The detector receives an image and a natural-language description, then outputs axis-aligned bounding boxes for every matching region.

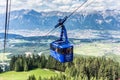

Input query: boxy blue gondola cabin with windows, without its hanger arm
[50,41,73,63]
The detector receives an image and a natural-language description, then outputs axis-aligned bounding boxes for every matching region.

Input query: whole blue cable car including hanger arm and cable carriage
[50,17,73,63]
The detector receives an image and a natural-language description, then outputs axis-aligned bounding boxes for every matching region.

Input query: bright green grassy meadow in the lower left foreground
[0,69,57,80]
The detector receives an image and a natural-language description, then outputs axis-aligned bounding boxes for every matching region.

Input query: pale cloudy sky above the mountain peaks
[0,0,120,13]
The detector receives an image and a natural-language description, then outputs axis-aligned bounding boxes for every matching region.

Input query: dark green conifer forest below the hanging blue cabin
[10,55,120,80]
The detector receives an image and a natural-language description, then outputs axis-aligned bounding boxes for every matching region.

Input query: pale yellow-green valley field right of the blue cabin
[74,42,120,56]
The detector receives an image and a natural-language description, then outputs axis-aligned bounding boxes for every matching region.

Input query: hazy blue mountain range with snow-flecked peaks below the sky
[0,9,120,30]
